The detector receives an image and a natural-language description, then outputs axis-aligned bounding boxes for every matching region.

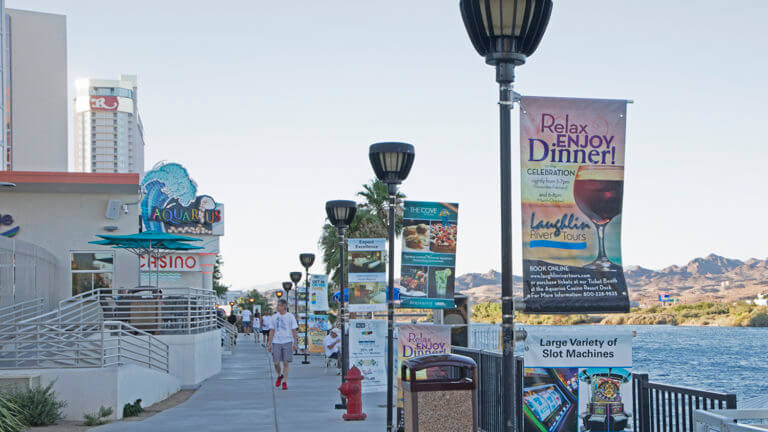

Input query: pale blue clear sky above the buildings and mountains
[7,0,768,289]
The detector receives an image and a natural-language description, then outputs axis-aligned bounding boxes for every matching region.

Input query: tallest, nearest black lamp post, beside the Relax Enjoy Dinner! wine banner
[459,0,552,432]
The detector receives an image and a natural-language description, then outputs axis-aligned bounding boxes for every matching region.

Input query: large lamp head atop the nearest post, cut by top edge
[459,0,552,65]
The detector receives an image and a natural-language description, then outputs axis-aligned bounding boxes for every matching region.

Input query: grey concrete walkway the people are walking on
[89,335,386,432]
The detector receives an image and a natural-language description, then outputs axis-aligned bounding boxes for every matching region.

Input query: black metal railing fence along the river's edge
[451,346,736,432]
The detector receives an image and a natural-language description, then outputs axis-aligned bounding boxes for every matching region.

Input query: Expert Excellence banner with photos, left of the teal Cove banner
[347,239,387,312]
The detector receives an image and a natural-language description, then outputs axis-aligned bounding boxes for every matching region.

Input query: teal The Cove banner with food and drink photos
[400,201,459,309]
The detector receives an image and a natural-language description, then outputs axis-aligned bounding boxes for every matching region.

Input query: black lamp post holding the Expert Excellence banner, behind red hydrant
[325,200,357,409]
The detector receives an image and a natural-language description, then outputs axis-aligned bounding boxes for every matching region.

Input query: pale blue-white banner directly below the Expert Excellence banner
[349,319,387,393]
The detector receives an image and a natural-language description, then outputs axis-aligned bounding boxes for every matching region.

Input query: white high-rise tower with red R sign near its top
[74,75,144,174]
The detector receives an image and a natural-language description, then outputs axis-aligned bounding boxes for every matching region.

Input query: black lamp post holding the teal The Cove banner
[368,142,416,432]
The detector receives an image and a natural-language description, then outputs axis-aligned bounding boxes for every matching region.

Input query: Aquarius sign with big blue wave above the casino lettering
[141,163,224,235]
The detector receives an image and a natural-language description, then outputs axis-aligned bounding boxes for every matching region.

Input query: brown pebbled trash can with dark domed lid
[401,354,477,432]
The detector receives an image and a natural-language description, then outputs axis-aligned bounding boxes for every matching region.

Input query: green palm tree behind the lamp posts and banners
[318,180,405,292]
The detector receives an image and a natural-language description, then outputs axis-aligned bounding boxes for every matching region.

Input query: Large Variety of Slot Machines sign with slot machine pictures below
[523,326,634,432]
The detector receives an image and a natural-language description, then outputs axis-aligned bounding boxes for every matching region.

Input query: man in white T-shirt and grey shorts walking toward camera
[267,299,299,390]
